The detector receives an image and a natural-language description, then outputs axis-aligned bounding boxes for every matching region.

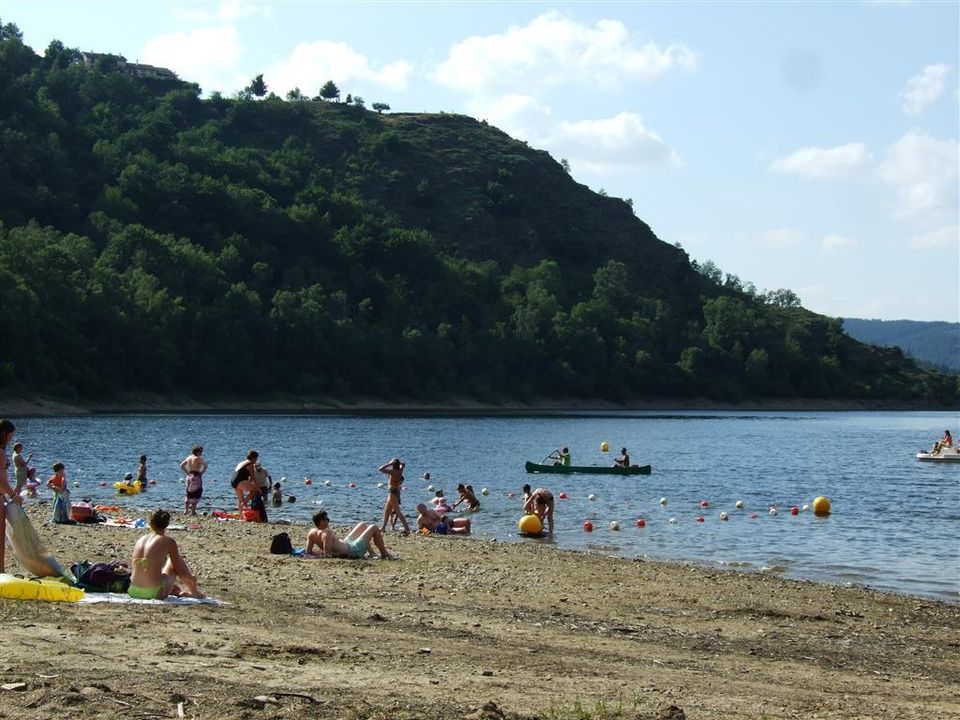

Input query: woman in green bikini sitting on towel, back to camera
[127,510,203,600]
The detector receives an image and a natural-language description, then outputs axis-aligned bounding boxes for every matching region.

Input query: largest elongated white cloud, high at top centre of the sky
[434,12,697,95]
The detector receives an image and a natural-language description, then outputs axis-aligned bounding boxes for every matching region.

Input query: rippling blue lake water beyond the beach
[14,412,960,602]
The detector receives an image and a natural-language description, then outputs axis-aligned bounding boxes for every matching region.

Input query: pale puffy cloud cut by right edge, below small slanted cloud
[878,130,960,218]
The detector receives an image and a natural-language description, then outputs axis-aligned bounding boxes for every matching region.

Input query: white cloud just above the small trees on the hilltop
[263,40,413,96]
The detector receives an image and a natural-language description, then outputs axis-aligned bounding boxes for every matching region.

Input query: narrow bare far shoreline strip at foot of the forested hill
[0,393,960,417]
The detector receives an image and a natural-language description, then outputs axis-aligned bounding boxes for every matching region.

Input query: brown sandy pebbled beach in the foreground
[0,507,960,720]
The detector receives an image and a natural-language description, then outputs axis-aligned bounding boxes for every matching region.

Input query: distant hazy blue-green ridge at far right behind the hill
[843,318,960,374]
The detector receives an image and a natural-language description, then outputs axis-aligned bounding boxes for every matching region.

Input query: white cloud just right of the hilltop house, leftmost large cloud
[139,25,249,94]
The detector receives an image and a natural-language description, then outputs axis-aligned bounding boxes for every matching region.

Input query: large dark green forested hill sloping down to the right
[0,25,957,403]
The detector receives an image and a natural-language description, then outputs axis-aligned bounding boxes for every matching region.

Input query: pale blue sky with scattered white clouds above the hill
[0,0,960,322]
